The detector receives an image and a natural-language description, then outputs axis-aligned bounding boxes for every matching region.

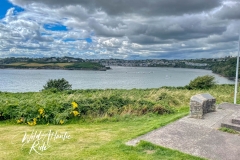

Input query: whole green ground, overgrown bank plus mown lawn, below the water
[0,85,236,159]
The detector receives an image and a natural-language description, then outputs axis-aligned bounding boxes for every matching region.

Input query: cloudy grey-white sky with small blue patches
[0,0,240,59]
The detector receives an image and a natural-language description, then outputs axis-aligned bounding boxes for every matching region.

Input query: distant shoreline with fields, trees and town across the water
[0,56,240,79]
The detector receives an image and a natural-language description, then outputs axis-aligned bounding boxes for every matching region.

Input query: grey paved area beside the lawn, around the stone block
[127,103,240,160]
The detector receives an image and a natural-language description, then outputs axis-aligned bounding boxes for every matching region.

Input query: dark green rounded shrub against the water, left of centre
[43,78,72,91]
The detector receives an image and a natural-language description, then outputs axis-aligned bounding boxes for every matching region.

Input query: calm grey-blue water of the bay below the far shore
[0,67,234,92]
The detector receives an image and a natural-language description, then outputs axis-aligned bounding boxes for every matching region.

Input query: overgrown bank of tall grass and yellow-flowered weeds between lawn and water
[0,85,234,124]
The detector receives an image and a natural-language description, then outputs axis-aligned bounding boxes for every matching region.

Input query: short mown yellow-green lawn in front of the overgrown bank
[0,108,204,160]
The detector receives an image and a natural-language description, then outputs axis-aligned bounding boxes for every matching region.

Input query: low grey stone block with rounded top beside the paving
[190,93,216,118]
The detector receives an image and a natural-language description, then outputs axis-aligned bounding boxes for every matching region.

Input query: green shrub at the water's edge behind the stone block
[188,75,216,89]
